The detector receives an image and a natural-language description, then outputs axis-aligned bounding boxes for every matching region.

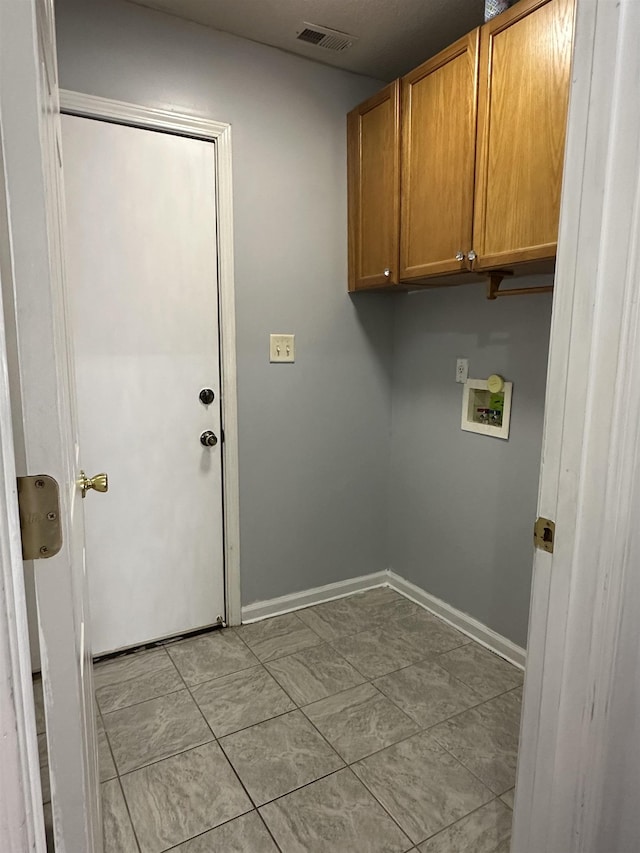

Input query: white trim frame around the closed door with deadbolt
[60,89,241,625]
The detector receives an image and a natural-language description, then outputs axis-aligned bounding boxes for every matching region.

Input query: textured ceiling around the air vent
[126,0,484,80]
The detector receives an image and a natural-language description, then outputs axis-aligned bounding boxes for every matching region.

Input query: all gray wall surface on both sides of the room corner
[57,0,551,644]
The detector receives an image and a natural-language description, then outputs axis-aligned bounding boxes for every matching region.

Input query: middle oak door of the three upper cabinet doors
[400,30,479,280]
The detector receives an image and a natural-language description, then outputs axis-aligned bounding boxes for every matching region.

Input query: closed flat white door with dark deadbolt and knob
[62,115,225,654]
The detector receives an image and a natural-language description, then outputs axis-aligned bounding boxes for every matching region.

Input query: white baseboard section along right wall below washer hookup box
[386,569,527,669]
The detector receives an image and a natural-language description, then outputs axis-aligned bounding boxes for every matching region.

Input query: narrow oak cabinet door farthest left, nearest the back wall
[347,80,400,290]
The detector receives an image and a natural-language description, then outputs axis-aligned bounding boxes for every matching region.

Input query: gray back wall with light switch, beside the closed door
[56,0,391,604]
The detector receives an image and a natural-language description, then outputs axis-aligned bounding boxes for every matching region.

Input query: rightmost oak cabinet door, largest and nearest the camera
[473,0,573,269]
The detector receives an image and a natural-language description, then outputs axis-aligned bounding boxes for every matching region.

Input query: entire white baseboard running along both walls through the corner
[242,569,526,669]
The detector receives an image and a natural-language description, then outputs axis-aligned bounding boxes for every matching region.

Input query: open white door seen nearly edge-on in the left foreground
[0,0,102,853]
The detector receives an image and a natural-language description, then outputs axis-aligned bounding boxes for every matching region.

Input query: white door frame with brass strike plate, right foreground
[512,0,640,853]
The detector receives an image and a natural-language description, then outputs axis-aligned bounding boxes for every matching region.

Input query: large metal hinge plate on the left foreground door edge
[18,474,62,560]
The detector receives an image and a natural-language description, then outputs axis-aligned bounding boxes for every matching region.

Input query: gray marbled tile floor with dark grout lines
[44,587,522,853]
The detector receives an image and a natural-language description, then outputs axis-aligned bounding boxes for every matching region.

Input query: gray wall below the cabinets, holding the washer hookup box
[390,279,551,646]
